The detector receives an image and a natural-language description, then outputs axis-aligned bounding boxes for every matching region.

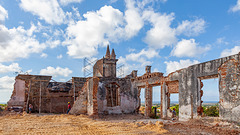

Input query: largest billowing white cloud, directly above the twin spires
[64,0,144,58]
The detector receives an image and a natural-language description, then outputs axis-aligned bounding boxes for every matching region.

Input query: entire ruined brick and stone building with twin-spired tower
[8,47,240,122]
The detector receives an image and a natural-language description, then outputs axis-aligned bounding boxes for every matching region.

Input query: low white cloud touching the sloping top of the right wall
[164,59,200,74]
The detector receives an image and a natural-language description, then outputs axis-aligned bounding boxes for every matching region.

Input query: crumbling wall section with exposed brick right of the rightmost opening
[218,59,240,122]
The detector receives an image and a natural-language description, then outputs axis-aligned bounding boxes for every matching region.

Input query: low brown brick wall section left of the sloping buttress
[8,75,86,113]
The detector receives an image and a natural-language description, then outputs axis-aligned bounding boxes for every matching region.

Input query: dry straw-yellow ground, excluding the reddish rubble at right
[0,114,167,135]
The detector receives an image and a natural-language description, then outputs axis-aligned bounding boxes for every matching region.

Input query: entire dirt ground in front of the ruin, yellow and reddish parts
[0,114,240,135]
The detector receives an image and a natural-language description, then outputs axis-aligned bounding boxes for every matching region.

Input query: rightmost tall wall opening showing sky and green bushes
[198,78,219,117]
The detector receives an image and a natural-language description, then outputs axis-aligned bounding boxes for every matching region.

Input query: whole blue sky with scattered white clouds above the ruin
[0,0,240,102]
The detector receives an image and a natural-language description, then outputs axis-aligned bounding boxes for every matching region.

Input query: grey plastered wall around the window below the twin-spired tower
[97,78,138,114]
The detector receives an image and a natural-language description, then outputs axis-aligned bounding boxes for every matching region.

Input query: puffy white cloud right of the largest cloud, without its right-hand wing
[143,11,177,49]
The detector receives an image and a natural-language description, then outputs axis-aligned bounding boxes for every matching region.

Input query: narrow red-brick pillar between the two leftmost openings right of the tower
[145,85,152,116]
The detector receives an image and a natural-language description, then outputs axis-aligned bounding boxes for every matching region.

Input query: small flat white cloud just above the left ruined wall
[40,66,72,77]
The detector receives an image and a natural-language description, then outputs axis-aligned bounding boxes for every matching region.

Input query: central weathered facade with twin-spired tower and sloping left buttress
[70,47,138,115]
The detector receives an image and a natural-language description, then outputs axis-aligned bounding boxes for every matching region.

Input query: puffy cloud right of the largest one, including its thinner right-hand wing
[143,9,206,49]
